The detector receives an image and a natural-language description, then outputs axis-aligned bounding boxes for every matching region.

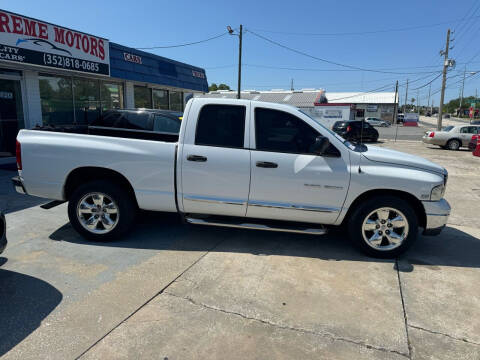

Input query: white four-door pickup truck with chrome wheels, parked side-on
[13,98,450,257]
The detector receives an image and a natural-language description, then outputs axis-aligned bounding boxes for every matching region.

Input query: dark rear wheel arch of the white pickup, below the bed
[63,166,138,207]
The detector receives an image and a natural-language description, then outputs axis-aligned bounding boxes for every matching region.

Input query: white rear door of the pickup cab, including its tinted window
[179,99,250,216]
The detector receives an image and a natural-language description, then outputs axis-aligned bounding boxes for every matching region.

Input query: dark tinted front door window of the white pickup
[255,108,320,154]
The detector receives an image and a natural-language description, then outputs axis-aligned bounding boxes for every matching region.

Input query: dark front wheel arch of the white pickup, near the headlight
[341,189,427,228]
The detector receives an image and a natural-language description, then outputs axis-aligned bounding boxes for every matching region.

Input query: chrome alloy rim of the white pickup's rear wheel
[77,192,120,234]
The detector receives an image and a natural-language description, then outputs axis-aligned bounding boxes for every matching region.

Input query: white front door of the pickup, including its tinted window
[247,104,350,224]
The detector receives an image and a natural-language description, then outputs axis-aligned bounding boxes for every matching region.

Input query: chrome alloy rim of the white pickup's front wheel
[362,207,408,251]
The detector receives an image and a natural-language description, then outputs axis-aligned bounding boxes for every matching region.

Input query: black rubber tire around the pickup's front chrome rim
[348,195,418,258]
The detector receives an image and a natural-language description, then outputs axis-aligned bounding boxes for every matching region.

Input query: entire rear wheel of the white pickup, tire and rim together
[68,180,136,241]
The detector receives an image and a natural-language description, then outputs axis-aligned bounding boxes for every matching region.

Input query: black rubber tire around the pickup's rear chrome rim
[68,180,137,241]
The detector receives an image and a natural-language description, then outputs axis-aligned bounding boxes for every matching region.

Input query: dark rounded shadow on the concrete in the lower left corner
[0,257,63,357]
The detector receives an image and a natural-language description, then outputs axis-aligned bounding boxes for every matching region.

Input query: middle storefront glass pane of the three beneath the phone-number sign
[73,78,100,124]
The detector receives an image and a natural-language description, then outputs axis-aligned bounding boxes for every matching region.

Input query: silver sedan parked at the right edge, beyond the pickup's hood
[422,125,480,150]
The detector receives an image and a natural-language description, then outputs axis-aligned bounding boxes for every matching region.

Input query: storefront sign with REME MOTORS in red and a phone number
[0,10,110,75]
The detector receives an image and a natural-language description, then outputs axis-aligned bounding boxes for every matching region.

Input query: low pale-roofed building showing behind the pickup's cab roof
[199,89,398,126]
